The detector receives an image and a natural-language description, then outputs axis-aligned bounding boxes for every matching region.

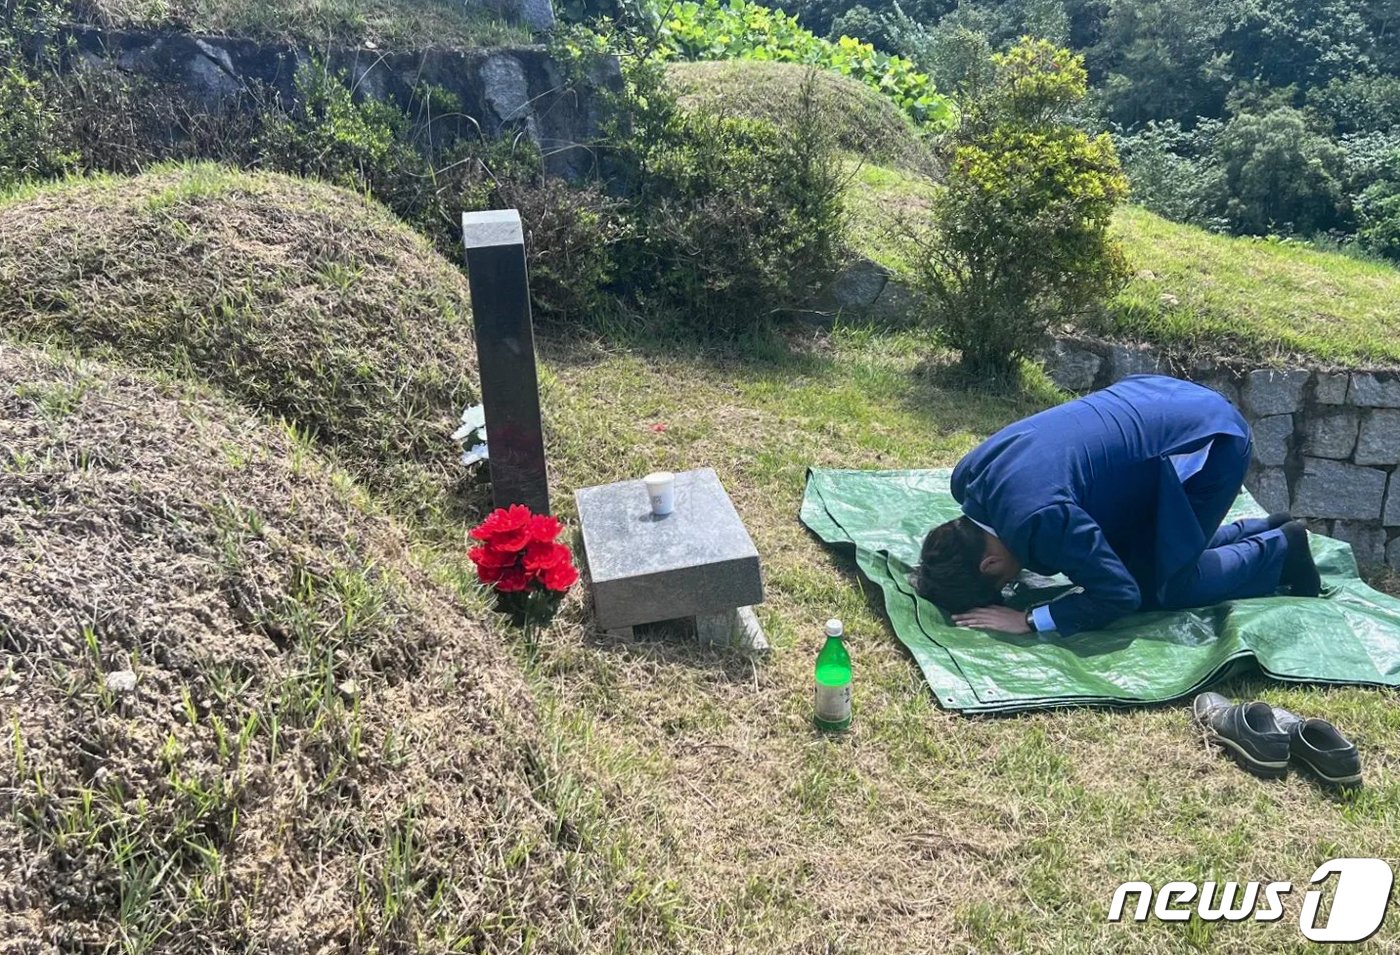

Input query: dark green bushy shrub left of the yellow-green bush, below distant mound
[617,64,844,336]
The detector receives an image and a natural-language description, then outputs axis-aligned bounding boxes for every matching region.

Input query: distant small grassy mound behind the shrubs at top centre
[666,60,928,168]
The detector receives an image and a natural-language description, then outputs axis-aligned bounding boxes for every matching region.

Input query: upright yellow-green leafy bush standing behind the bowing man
[911,39,1127,375]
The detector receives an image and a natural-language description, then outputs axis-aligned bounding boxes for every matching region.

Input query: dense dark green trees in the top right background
[777,0,1400,252]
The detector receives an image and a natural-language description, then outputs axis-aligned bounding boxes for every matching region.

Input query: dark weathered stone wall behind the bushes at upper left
[51,25,622,178]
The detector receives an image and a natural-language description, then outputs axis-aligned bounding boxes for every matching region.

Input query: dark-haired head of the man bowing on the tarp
[910,517,1021,613]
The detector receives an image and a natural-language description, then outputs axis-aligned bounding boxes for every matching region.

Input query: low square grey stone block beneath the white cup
[574,468,763,630]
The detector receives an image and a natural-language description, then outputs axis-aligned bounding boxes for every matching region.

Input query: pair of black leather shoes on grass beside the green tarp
[1191,693,1361,787]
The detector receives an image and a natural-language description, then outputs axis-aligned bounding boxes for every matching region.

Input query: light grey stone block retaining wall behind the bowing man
[1046,339,1400,570]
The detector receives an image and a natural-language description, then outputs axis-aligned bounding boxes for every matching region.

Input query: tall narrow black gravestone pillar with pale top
[462,209,549,514]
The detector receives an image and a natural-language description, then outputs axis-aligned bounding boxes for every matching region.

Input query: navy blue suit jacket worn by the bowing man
[952,375,1250,634]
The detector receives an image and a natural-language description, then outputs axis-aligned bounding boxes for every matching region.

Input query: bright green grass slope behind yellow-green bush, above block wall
[848,164,1400,365]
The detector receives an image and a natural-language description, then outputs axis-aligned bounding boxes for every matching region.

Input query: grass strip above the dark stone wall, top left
[70,0,529,48]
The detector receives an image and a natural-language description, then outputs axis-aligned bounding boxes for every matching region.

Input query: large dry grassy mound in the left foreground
[0,344,574,954]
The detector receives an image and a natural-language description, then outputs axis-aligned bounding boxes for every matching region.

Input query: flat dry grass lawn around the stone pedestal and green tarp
[526,328,1400,954]
